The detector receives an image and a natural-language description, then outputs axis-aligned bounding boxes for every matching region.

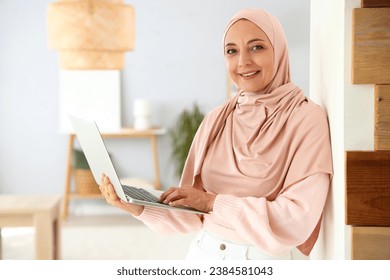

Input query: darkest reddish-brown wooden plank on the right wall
[345,151,390,226]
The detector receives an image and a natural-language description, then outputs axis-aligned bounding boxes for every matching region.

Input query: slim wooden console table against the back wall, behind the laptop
[63,127,166,219]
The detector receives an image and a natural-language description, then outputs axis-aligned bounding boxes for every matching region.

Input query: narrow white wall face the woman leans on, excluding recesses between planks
[310,0,345,259]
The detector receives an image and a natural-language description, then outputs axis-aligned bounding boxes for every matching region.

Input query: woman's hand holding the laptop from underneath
[99,174,144,216]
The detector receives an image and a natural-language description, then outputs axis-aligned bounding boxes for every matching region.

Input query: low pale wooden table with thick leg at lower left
[0,195,61,260]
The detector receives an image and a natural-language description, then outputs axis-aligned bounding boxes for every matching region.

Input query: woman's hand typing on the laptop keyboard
[160,187,216,213]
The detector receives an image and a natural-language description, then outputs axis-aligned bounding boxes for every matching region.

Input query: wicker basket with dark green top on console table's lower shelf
[72,149,100,195]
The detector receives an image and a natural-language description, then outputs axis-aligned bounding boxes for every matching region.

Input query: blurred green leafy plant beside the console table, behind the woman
[169,103,204,177]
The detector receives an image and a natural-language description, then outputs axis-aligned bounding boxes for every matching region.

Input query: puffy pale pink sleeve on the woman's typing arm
[213,173,330,255]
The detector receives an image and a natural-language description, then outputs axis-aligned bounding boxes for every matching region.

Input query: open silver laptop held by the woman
[68,114,205,214]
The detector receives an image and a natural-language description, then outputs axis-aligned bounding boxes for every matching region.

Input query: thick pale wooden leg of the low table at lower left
[34,212,55,260]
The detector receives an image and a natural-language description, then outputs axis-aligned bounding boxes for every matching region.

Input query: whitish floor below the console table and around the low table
[1,215,195,260]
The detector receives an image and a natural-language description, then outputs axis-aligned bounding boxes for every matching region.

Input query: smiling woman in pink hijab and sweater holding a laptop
[100,10,333,259]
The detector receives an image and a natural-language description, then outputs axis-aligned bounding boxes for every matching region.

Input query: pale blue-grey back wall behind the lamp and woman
[0,0,310,197]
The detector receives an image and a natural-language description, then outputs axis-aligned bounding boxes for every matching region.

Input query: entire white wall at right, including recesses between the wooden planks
[310,0,374,259]
